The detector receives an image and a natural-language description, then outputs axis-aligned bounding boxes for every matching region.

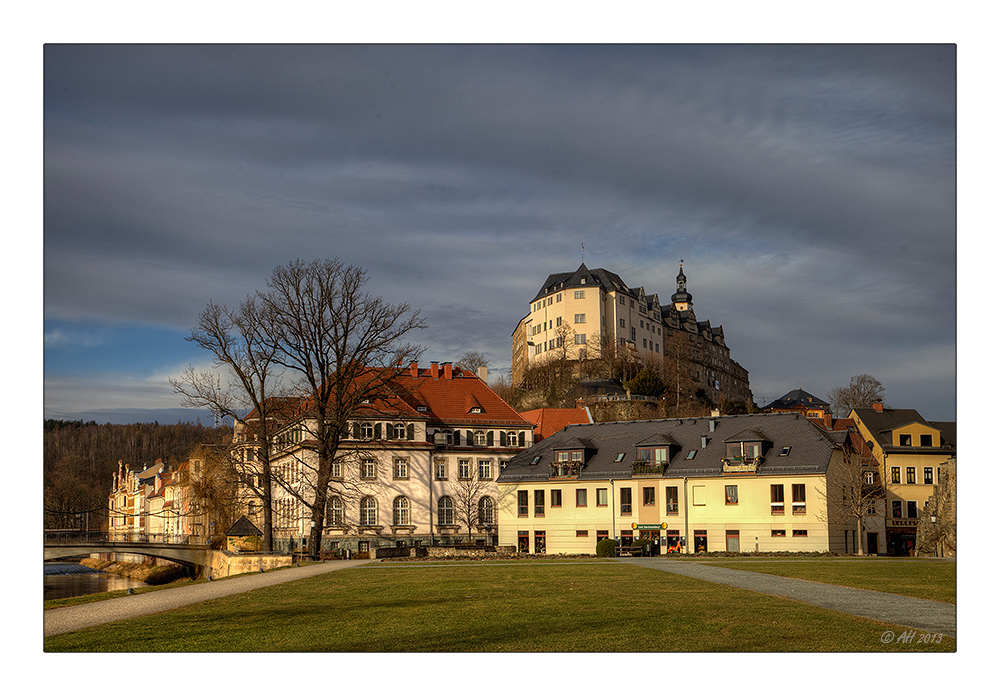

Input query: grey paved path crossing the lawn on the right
[622,558,957,638]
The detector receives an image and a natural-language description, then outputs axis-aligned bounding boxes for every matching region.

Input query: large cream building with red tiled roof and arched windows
[234,363,532,553]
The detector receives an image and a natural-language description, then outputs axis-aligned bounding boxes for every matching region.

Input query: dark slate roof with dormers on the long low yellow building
[497,413,843,483]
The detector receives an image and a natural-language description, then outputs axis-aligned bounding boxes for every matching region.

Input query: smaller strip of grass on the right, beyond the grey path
[711,558,956,604]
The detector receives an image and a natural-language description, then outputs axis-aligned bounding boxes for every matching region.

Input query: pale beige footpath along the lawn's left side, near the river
[44,560,371,636]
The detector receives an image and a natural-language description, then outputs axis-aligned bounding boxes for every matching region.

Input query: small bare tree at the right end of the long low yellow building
[820,433,886,555]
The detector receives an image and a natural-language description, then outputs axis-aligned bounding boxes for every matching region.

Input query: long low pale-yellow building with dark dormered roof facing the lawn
[497,413,858,554]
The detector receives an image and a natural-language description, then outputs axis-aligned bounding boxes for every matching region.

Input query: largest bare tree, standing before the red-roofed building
[256,259,426,555]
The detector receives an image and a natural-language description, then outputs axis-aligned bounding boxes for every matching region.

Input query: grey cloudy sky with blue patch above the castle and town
[43,44,957,422]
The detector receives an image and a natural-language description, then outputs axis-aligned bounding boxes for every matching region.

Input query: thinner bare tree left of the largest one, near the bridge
[170,297,283,553]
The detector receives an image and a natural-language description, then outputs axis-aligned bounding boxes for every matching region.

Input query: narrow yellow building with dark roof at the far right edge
[850,402,955,556]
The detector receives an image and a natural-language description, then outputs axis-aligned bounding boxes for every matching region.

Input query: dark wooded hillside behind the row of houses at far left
[43,420,232,529]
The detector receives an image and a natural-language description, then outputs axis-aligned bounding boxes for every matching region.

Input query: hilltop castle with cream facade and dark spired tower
[511,264,753,403]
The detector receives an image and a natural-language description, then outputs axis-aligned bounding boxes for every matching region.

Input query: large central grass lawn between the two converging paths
[45,563,955,652]
